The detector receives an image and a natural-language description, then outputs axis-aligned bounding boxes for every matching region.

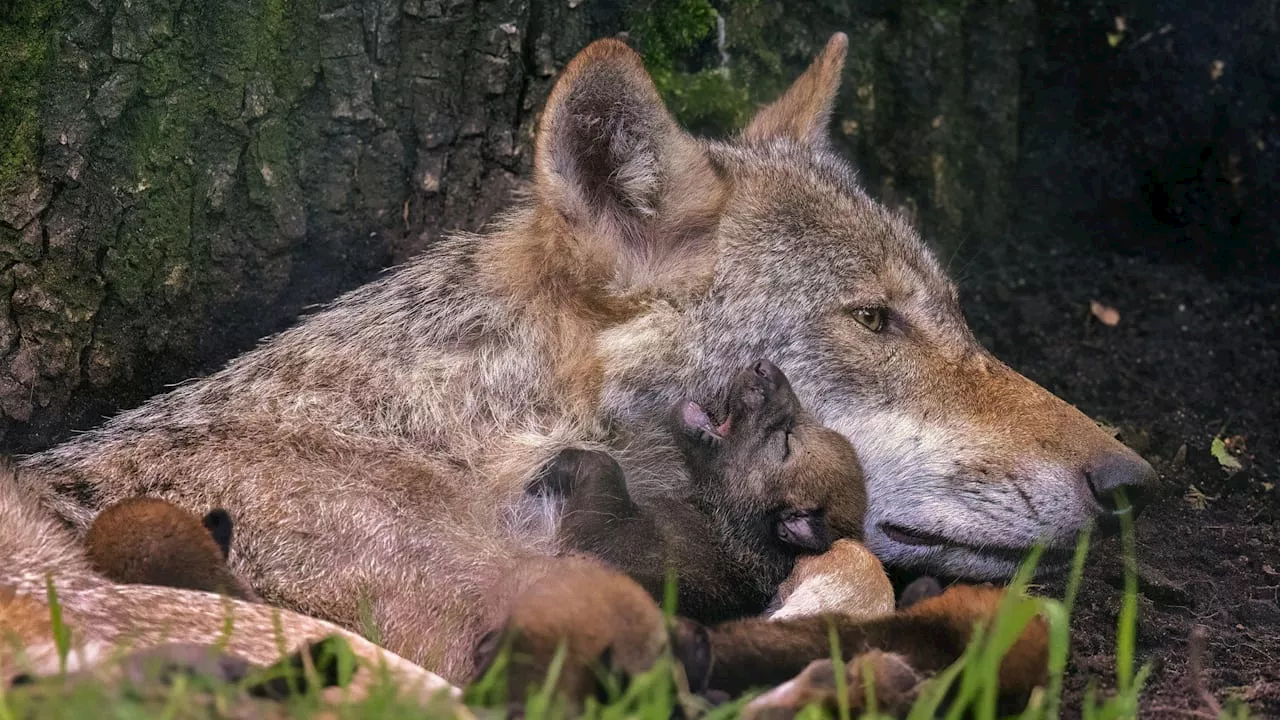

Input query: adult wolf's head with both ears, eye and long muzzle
[524,35,1155,578]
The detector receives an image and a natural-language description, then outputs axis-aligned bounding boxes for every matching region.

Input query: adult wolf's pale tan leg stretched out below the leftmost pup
[0,457,467,716]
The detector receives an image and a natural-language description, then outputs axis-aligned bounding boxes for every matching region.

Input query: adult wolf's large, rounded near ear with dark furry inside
[534,40,722,292]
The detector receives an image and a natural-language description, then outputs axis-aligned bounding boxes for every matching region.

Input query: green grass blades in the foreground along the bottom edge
[0,500,1203,720]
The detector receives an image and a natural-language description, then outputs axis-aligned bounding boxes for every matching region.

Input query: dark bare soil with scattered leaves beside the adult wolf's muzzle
[952,222,1280,717]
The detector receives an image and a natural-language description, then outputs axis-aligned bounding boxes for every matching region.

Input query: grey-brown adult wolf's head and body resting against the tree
[15,35,1152,679]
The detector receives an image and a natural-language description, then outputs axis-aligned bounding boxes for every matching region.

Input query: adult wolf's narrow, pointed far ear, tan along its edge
[742,32,849,147]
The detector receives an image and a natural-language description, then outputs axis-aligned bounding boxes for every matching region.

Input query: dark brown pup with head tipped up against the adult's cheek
[531,360,870,623]
